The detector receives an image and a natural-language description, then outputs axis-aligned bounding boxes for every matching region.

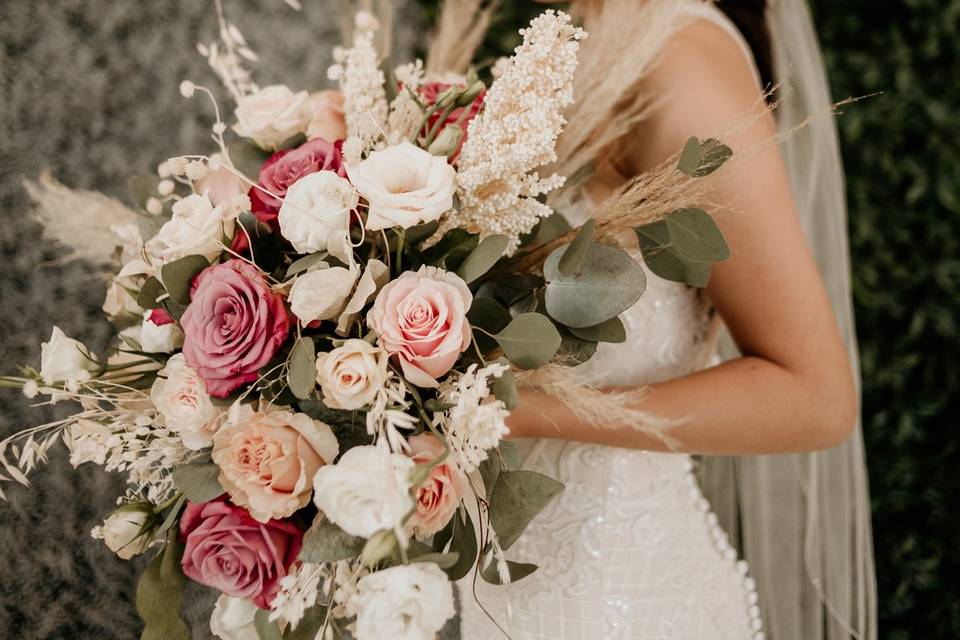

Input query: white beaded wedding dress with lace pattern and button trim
[459,5,764,640]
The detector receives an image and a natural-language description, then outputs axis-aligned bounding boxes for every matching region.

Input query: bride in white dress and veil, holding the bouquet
[444,0,876,640]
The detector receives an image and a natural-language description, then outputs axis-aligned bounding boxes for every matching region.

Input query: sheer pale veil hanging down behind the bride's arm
[701,0,877,640]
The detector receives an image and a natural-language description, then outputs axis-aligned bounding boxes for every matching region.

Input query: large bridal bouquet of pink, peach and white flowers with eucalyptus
[0,5,730,640]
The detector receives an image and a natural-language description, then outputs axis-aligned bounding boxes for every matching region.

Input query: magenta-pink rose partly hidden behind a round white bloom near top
[249,138,347,224]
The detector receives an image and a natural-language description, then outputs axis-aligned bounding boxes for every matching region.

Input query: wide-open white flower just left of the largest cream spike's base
[347,142,457,231]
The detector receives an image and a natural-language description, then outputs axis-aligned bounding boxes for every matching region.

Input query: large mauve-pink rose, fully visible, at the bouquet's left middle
[180,260,290,398]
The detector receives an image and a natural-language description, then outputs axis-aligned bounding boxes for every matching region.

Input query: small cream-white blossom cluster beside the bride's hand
[435,362,510,473]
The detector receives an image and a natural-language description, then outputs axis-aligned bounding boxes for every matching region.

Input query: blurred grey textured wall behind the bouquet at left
[0,0,424,640]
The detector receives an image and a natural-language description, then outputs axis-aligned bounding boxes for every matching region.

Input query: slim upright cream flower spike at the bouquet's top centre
[327,11,387,152]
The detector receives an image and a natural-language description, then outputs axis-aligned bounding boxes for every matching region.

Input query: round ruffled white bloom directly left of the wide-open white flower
[277,171,360,253]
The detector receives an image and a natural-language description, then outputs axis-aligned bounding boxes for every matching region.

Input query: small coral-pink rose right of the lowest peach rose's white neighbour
[407,433,467,539]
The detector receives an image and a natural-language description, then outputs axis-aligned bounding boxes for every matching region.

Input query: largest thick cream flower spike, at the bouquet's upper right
[438,10,586,252]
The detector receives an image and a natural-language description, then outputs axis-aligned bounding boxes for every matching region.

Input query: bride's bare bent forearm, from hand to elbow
[508,356,857,454]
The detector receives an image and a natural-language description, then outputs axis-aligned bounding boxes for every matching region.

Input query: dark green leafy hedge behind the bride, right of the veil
[422,0,960,640]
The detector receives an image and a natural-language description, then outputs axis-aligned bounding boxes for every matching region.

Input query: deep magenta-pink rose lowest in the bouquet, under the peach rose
[180,499,303,609]
